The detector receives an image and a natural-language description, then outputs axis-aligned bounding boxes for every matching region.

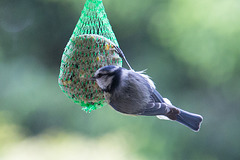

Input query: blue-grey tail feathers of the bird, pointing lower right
[176,109,203,132]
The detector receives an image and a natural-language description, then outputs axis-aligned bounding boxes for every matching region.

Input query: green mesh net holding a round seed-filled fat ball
[58,0,122,112]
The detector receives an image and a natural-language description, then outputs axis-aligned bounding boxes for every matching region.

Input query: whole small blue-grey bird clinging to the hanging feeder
[90,65,203,132]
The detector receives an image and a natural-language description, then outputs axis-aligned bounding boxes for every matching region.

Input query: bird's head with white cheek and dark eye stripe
[91,65,121,92]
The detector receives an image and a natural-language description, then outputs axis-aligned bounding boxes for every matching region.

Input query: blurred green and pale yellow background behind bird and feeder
[0,0,240,160]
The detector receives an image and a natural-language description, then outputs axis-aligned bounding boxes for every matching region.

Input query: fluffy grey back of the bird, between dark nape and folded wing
[110,71,151,114]
